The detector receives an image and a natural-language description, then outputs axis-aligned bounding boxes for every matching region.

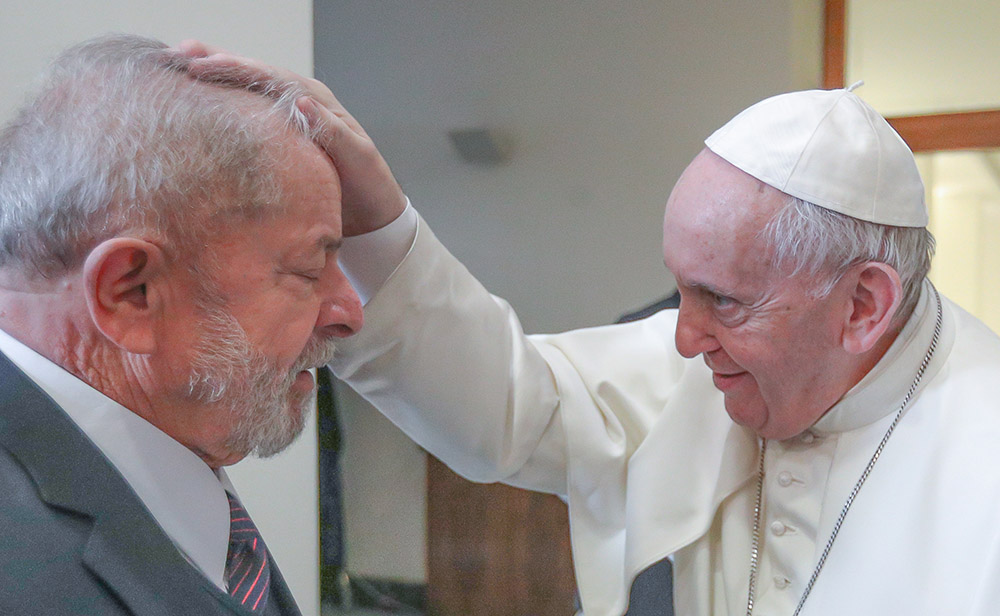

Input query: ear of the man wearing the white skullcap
[843,261,903,354]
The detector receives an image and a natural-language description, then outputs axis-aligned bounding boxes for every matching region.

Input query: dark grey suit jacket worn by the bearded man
[0,354,299,616]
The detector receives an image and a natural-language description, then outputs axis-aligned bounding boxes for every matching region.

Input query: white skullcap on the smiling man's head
[705,86,927,227]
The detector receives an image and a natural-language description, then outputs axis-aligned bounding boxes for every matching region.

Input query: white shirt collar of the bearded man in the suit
[0,330,233,588]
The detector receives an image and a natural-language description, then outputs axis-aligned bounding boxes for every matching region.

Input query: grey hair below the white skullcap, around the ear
[760,196,934,323]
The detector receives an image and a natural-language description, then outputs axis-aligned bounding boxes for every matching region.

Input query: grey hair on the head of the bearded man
[0,35,320,277]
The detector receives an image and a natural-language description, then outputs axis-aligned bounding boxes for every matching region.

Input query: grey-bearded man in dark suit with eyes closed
[0,36,362,616]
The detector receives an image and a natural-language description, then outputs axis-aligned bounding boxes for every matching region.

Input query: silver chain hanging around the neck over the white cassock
[747,287,942,616]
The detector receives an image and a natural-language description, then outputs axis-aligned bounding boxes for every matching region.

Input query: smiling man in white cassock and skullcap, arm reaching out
[189,46,1000,616]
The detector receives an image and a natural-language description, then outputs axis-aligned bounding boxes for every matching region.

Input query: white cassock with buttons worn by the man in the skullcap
[332,213,1000,616]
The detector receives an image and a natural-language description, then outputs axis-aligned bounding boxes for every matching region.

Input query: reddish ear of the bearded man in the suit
[83,237,165,353]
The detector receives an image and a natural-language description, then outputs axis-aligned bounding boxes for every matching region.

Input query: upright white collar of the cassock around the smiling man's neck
[811,280,954,434]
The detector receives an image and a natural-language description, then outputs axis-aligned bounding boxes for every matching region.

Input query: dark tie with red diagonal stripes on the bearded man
[226,492,271,612]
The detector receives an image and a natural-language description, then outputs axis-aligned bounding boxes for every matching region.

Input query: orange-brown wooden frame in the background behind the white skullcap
[823,0,1000,152]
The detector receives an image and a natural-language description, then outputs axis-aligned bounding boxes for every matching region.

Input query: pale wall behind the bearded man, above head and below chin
[0,6,319,616]
